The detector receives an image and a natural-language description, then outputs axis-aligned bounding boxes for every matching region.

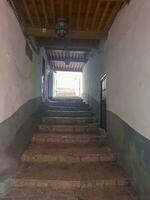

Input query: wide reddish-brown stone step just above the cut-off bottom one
[12,163,128,190]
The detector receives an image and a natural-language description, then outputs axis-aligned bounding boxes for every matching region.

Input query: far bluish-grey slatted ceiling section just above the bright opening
[46,49,89,72]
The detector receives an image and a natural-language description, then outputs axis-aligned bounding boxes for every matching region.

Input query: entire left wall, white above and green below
[0,0,42,176]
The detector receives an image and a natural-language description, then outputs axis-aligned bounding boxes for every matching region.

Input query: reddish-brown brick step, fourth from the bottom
[32,133,106,144]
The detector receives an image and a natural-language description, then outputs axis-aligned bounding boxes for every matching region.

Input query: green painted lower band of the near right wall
[107,111,150,200]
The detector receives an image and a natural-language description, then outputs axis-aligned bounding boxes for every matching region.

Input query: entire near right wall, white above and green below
[105,0,150,200]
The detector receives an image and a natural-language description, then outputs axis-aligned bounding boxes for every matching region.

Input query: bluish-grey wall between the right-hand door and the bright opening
[83,43,105,122]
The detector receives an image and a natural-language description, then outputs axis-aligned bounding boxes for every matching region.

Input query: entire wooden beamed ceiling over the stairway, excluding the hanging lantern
[8,0,128,71]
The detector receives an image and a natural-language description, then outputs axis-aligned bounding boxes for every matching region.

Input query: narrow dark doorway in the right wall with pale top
[100,75,107,130]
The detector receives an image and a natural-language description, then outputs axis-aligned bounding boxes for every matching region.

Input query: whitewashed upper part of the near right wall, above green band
[106,0,150,139]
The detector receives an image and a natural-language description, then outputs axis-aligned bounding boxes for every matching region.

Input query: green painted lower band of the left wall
[0,97,41,177]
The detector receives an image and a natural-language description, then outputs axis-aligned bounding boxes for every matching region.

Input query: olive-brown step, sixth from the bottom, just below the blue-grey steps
[42,117,97,125]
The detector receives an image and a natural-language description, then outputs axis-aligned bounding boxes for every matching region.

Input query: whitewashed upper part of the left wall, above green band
[0,0,41,122]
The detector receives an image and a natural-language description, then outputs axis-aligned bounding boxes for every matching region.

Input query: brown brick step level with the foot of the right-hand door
[39,123,98,133]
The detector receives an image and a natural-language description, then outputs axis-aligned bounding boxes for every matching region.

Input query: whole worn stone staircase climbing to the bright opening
[1,98,137,200]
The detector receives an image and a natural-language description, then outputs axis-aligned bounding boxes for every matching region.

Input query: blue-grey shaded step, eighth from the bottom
[45,105,91,111]
